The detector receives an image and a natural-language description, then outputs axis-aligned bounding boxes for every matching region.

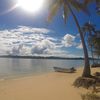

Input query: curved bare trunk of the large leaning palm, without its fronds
[66,0,91,77]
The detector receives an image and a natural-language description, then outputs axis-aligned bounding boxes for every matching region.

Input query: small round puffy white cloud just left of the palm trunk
[62,34,75,47]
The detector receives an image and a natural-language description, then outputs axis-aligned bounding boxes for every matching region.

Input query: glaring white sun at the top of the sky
[17,0,44,12]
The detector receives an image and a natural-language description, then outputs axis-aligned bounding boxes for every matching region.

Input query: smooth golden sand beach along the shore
[0,68,100,100]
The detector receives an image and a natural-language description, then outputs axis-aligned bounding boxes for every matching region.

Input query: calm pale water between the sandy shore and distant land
[0,58,83,78]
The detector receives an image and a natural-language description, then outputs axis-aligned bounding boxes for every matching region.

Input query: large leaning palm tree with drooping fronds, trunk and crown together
[48,0,91,77]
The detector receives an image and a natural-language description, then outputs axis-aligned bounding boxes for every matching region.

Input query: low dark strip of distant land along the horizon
[0,55,98,60]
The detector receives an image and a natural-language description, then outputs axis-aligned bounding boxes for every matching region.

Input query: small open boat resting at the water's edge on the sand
[53,67,76,73]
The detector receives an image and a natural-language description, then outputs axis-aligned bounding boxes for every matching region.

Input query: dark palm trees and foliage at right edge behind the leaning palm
[82,22,100,65]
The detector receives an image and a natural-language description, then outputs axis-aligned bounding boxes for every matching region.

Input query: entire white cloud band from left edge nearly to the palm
[0,26,81,56]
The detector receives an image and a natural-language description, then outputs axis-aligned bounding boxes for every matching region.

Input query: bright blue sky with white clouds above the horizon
[0,0,100,57]
